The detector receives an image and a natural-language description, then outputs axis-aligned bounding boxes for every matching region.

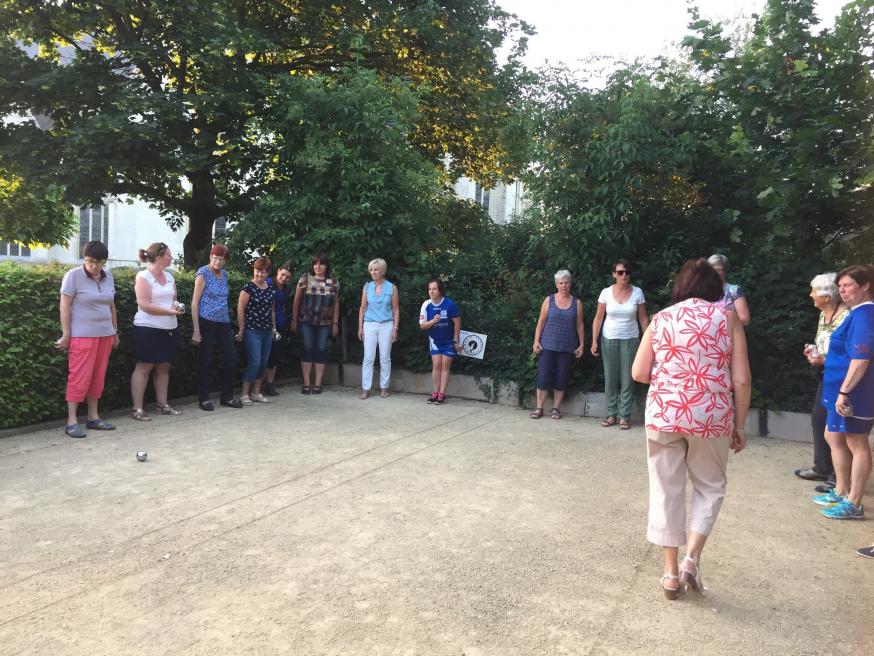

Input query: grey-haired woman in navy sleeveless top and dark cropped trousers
[528,269,586,419]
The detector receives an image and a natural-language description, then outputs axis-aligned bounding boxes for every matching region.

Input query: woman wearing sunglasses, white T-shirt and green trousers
[591,259,649,430]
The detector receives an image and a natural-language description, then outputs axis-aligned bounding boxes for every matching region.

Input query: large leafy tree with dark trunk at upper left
[0,0,528,262]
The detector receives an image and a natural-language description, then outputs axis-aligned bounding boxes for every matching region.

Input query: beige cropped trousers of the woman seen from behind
[646,428,731,547]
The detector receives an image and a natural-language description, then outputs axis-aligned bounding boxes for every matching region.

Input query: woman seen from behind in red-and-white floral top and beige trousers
[632,259,750,599]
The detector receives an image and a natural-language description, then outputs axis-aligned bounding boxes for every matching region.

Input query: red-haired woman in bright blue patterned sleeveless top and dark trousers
[191,244,243,412]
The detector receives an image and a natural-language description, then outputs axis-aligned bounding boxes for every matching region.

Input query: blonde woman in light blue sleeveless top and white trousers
[358,258,400,400]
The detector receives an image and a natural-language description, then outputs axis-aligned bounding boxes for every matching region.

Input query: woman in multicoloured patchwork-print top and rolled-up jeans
[291,253,340,394]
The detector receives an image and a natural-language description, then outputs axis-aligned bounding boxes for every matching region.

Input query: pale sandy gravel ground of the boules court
[0,388,874,656]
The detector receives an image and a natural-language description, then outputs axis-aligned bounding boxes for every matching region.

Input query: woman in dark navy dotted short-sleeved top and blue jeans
[237,257,279,405]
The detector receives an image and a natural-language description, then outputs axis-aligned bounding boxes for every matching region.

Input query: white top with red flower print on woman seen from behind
[646,298,734,437]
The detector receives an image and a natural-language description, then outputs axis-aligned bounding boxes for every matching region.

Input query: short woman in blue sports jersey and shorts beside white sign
[419,278,461,404]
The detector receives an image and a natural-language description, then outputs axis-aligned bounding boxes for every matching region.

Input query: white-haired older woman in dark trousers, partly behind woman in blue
[795,273,850,482]
